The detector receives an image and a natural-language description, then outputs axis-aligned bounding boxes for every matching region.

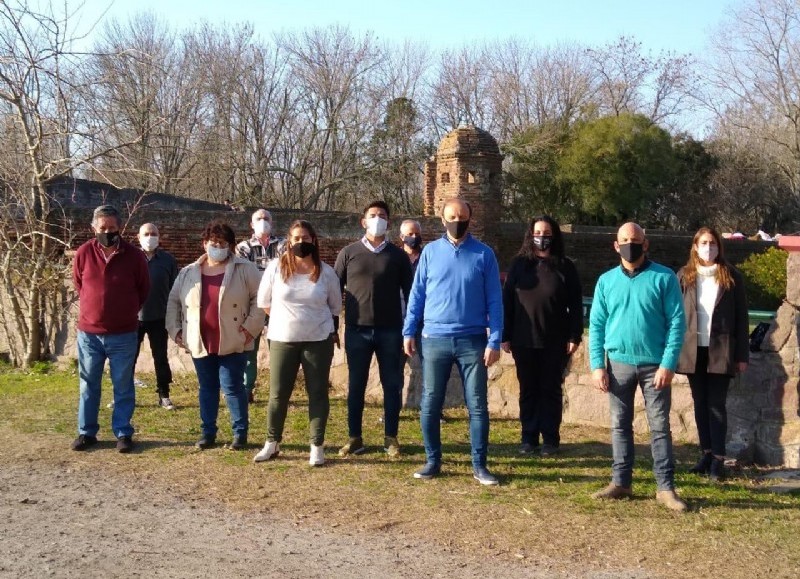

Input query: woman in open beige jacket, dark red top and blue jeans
[166,221,264,450]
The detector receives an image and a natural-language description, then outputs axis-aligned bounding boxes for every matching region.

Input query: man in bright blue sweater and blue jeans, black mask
[403,198,503,485]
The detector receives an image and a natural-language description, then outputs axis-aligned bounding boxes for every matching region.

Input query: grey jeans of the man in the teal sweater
[608,361,675,491]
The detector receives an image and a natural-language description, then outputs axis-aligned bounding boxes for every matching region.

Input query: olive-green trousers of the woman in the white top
[267,338,333,446]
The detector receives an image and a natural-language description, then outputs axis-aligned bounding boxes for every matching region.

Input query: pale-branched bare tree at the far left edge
[0,0,97,366]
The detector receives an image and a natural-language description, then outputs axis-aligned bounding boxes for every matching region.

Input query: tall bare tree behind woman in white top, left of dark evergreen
[278,26,389,210]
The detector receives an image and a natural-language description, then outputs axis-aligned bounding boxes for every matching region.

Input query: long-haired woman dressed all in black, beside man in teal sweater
[501,215,583,456]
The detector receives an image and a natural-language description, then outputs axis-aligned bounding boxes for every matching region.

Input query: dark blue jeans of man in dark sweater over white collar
[344,326,405,437]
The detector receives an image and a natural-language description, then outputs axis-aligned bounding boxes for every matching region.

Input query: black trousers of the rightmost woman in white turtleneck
[686,346,731,456]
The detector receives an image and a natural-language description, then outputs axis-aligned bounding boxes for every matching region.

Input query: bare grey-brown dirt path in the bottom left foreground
[0,434,644,578]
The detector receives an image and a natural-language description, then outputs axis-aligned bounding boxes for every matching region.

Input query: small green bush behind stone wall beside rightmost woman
[738,247,788,310]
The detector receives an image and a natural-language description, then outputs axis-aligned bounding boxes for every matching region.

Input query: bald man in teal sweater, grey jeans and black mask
[589,223,686,511]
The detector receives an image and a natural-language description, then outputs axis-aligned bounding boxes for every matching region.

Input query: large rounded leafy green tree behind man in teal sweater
[556,113,675,225]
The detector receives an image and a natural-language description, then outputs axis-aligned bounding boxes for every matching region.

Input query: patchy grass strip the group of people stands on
[0,370,800,577]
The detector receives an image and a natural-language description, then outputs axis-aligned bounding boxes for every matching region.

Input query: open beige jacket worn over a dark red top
[166,255,264,358]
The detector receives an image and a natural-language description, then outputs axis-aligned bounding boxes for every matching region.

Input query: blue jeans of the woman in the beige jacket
[192,352,248,438]
